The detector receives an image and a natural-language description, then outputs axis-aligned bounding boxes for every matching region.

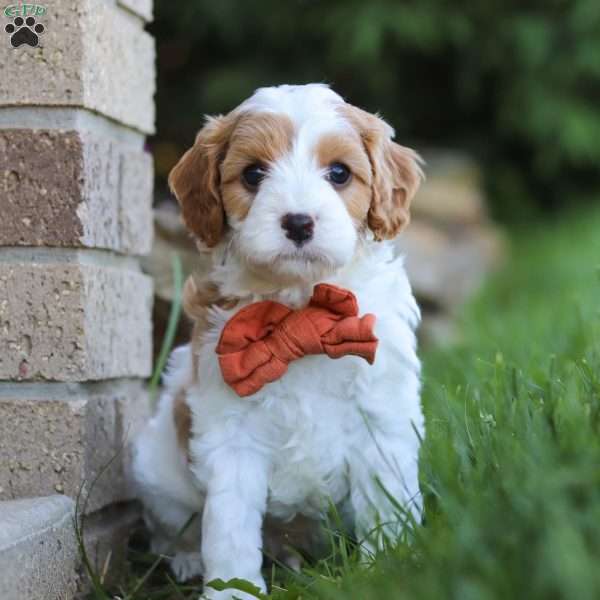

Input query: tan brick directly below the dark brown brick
[0,258,152,381]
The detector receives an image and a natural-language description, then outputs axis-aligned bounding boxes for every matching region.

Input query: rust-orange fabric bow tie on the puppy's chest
[216,283,377,396]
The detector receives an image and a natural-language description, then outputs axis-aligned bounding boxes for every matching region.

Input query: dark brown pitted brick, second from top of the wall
[0,129,152,254]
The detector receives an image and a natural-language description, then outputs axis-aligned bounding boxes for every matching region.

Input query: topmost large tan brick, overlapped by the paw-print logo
[0,0,155,133]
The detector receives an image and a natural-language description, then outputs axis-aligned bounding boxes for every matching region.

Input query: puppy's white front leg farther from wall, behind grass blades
[350,431,422,553]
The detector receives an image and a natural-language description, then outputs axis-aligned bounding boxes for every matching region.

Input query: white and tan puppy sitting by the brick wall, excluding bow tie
[134,84,424,599]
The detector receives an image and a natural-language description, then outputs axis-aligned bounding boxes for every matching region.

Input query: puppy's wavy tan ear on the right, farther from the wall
[348,106,423,241]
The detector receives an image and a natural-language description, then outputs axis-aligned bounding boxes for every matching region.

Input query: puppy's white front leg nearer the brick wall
[197,448,268,600]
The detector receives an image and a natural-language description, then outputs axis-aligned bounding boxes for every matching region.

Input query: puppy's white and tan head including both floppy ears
[169,85,421,282]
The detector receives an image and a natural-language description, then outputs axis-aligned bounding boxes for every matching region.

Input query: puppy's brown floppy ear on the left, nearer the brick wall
[169,115,236,248]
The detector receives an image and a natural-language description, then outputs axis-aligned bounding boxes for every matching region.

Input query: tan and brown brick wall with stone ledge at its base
[0,0,154,600]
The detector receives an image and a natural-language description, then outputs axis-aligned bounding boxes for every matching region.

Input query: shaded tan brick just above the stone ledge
[0,381,149,511]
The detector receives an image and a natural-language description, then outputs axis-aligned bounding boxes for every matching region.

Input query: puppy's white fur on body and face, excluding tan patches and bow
[134,86,424,600]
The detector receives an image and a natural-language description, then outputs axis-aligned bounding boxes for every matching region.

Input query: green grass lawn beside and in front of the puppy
[88,211,600,600]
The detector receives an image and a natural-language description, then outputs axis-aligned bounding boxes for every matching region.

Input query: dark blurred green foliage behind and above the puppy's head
[152,0,600,219]
